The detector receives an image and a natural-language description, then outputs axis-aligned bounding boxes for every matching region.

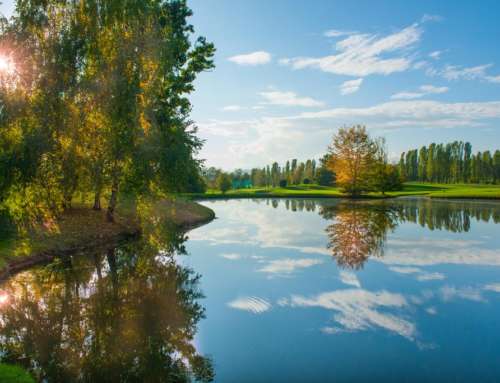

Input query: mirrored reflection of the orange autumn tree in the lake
[320,202,397,269]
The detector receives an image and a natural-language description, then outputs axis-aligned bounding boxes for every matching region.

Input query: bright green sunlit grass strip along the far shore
[185,183,500,199]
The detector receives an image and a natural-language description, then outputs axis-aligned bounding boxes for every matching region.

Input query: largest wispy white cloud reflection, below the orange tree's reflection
[279,289,416,340]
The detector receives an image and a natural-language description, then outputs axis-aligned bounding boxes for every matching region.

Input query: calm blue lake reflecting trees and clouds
[0,198,500,382]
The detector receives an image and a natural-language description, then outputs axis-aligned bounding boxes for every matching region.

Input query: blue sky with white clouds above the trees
[1,0,500,169]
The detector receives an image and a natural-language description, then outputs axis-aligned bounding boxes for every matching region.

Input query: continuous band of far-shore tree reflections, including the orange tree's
[274,198,500,270]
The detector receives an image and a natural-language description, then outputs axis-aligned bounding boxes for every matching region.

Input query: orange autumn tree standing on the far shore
[327,125,380,196]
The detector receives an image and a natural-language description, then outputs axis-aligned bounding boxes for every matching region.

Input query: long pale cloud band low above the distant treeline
[197,100,500,169]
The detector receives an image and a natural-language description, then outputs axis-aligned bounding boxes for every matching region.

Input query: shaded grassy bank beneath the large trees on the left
[0,198,215,278]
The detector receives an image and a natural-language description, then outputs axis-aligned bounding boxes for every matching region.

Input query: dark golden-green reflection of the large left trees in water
[0,231,213,382]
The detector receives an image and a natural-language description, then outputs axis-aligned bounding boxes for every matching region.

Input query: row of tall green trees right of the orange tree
[399,141,500,183]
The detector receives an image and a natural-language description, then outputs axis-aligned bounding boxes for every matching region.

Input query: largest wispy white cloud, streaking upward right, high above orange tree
[280,24,422,77]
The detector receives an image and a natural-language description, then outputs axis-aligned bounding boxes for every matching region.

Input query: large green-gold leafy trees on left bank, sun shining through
[0,0,214,228]
